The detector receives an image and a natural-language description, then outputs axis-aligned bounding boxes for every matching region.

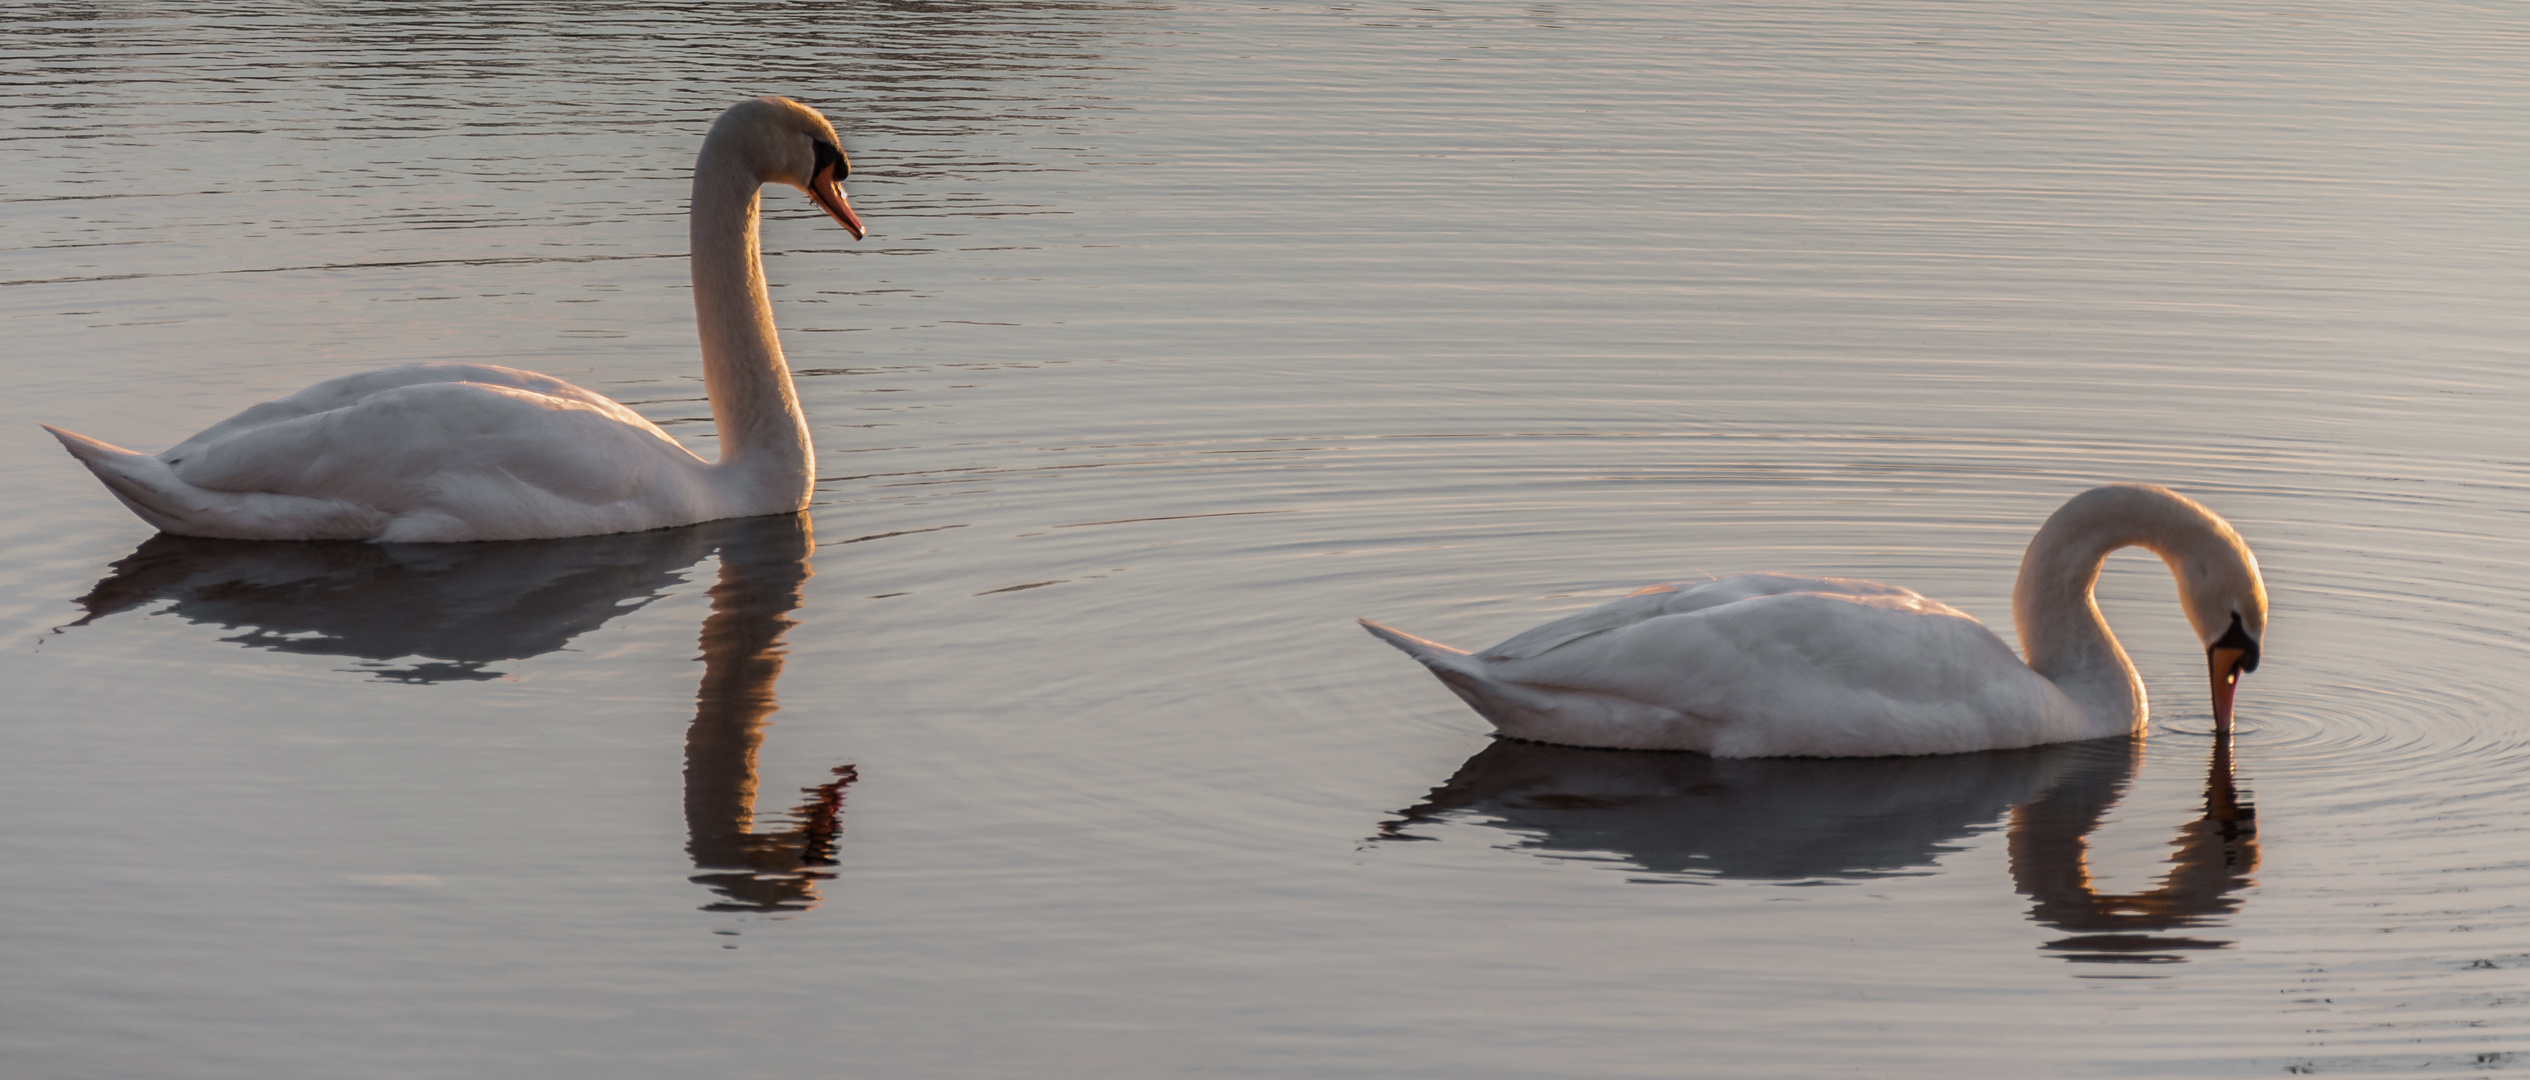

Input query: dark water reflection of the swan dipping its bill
[1379,736,2257,964]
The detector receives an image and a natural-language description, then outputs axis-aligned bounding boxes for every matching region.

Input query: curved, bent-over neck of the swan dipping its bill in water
[2011,486,2221,726]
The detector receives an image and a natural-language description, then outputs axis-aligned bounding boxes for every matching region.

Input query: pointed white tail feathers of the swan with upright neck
[43,425,385,539]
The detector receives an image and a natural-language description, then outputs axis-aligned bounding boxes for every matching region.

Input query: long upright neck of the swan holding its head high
[688,129,817,513]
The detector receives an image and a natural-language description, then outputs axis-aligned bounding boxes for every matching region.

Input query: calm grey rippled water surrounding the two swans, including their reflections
[0,3,2530,1080]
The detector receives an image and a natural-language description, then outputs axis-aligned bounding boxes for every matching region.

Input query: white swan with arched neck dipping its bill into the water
[1361,483,2267,756]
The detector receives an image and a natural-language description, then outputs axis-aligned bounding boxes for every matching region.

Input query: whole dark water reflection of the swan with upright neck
[73,513,858,911]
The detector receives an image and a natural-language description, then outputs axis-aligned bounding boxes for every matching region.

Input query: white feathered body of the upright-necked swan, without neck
[53,364,738,541]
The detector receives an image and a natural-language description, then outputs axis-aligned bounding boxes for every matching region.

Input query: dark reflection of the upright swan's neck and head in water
[686,513,860,911]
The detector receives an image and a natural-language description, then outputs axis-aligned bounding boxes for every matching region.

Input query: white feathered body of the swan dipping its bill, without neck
[1364,574,2143,756]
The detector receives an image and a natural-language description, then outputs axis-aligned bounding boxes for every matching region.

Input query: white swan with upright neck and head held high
[43,96,868,541]
